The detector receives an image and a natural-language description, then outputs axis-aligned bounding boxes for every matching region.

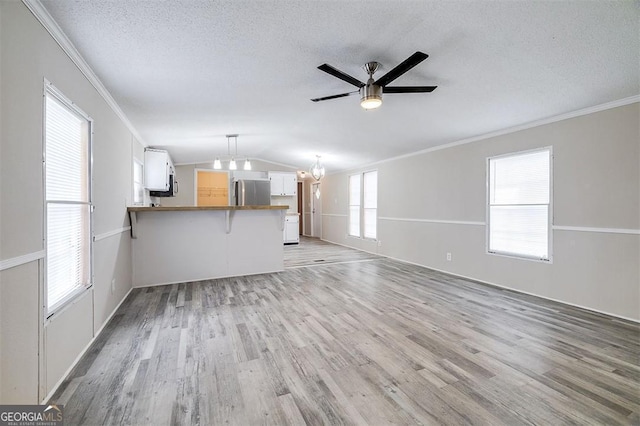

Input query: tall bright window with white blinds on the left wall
[44,85,92,315]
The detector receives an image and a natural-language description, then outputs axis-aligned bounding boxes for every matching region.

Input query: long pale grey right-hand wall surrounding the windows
[322,103,640,321]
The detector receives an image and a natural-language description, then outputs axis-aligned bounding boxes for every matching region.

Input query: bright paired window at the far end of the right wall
[349,171,378,239]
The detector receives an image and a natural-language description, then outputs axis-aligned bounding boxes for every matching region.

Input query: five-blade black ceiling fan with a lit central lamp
[311,52,438,109]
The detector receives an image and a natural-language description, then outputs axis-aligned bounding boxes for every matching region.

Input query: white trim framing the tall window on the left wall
[41,78,95,321]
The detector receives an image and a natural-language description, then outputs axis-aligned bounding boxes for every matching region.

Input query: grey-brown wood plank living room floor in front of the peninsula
[49,240,640,425]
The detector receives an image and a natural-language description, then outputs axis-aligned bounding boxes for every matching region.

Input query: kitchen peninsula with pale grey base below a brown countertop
[127,206,288,287]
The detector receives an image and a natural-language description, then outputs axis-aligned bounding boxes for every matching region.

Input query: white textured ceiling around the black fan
[42,0,640,172]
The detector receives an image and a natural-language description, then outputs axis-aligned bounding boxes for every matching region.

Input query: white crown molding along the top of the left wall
[22,0,147,146]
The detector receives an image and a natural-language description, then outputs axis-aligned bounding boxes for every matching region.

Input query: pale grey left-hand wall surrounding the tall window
[0,1,142,404]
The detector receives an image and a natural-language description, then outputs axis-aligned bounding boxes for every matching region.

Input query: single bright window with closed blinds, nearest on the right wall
[487,148,551,260]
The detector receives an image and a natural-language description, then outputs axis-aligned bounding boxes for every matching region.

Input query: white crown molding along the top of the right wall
[336,95,640,176]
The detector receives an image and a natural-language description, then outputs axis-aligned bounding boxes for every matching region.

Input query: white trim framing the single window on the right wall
[485,146,554,264]
